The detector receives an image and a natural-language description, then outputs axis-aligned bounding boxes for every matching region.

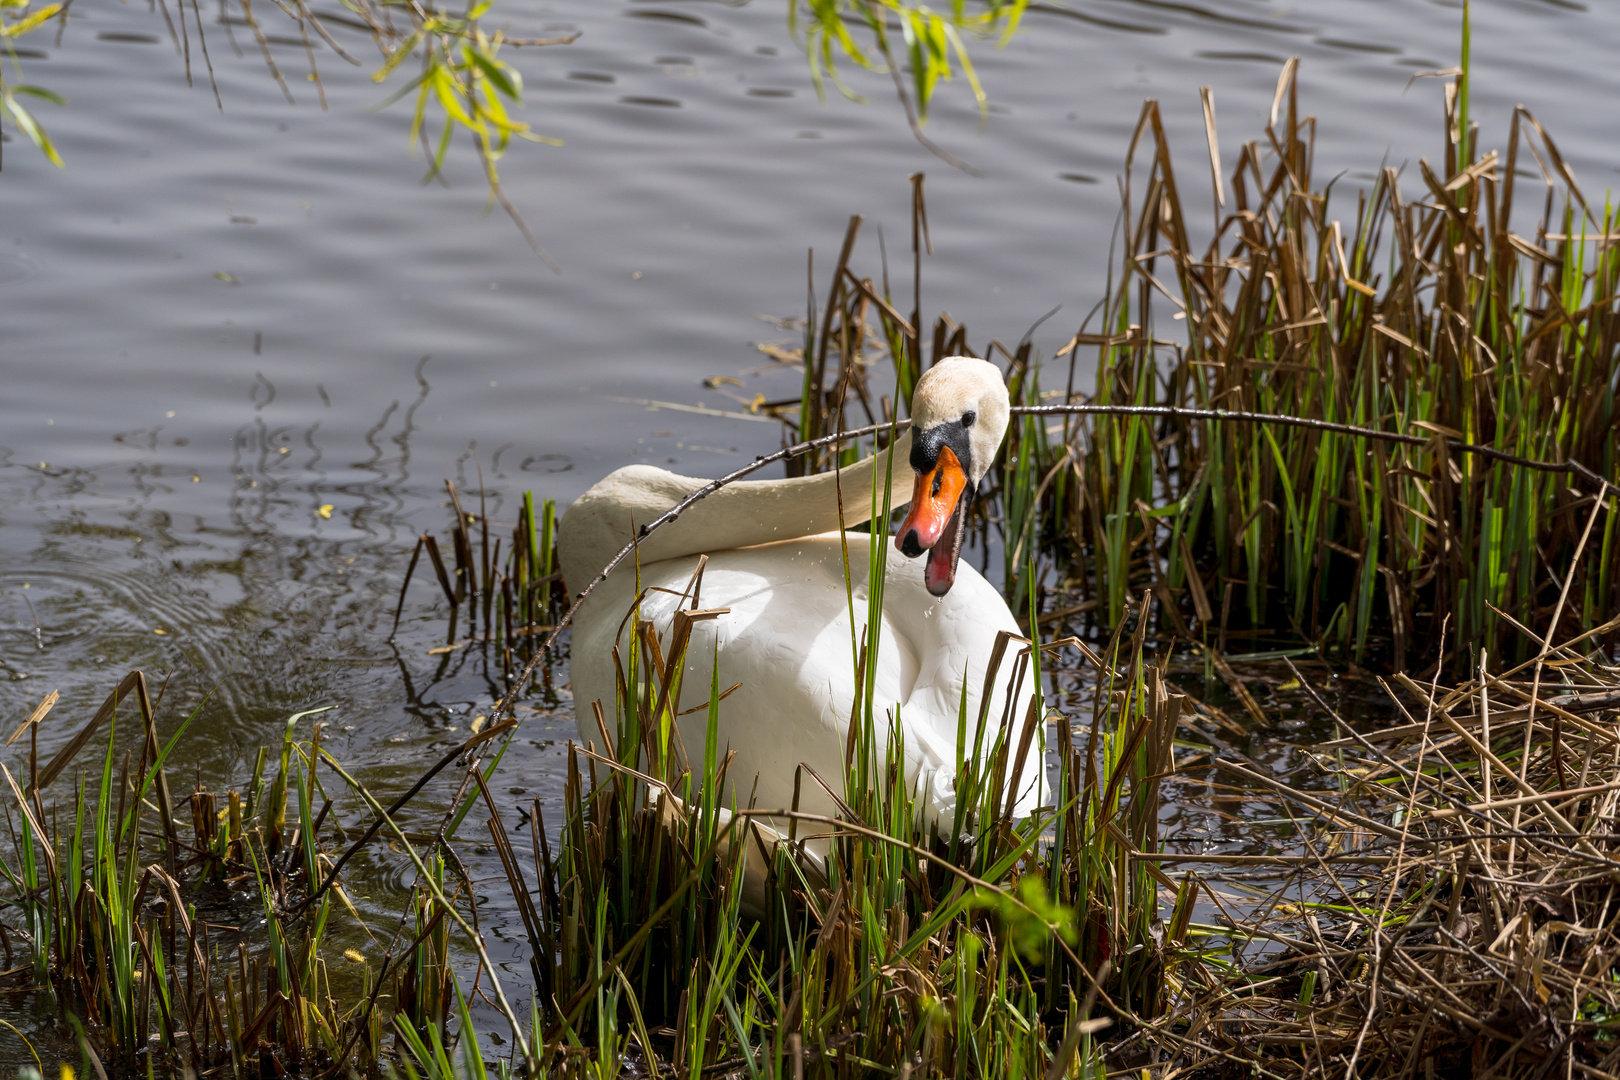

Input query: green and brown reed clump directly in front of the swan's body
[507,478,1218,1077]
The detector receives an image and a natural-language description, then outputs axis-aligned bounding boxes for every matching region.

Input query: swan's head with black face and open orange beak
[894,356,1009,596]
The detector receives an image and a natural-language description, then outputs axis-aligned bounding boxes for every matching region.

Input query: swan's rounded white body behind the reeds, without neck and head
[572,533,1042,827]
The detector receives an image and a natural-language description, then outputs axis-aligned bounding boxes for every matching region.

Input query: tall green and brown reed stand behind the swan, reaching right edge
[754,63,1620,669]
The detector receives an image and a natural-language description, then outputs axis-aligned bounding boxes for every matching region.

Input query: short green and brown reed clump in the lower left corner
[0,672,511,1077]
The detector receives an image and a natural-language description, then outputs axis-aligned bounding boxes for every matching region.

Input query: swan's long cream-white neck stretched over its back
[559,431,912,591]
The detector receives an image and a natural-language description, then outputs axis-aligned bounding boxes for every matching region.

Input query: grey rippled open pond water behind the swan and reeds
[0,0,1620,1069]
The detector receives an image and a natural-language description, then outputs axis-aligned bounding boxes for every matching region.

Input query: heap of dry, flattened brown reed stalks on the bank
[1134,625,1620,1080]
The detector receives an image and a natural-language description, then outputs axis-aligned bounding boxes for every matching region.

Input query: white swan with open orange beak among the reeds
[559,356,1043,832]
